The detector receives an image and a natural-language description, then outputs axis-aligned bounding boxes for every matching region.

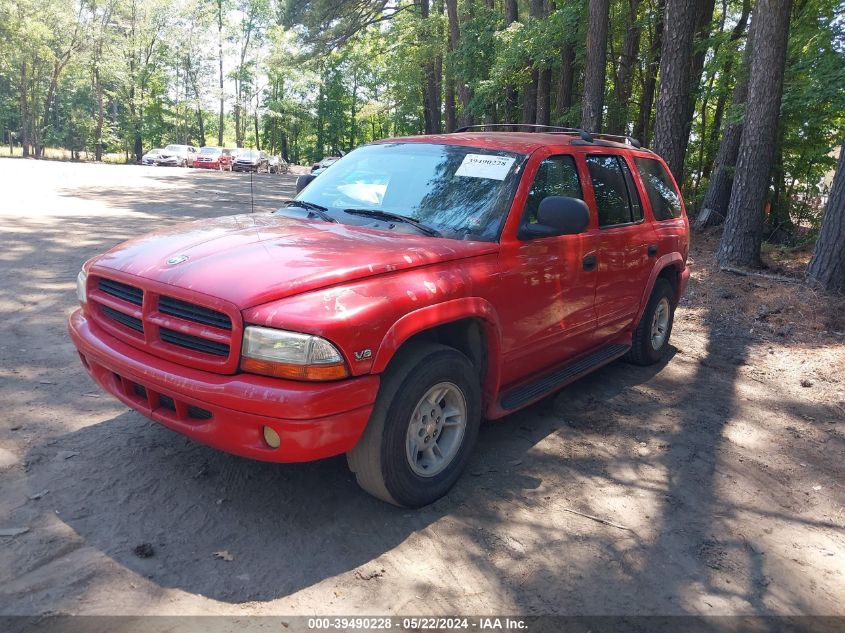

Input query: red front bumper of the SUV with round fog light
[68,310,379,462]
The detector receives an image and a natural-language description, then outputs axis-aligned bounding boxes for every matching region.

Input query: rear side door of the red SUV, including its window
[585,152,657,340]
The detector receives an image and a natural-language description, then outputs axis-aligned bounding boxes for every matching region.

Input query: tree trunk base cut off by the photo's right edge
[807,140,845,293]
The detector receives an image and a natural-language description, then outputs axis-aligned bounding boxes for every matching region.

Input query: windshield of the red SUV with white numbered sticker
[297,143,525,241]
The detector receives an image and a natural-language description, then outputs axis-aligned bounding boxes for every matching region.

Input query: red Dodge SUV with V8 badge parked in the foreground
[70,126,689,507]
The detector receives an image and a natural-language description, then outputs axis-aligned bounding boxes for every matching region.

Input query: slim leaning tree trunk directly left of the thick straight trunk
[696,21,753,229]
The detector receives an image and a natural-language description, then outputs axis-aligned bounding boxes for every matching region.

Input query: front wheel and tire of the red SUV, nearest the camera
[346,343,481,508]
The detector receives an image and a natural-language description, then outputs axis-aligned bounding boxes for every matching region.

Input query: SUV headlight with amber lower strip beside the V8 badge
[241,325,349,380]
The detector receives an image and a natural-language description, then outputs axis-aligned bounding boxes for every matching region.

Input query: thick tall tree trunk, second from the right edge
[716,0,792,266]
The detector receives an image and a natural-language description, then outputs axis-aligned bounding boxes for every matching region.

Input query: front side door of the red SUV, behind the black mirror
[497,154,599,385]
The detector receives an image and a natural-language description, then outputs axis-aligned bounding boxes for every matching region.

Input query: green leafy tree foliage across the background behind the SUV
[0,0,845,239]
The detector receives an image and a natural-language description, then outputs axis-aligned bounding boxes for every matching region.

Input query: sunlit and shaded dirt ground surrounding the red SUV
[0,159,845,615]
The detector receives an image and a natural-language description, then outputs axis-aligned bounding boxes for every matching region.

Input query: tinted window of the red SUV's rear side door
[587,154,642,227]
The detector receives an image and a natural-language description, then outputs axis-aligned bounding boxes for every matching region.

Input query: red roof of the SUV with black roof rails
[377,132,651,154]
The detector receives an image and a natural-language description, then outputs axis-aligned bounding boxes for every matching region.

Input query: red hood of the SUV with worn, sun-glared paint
[92,214,497,309]
